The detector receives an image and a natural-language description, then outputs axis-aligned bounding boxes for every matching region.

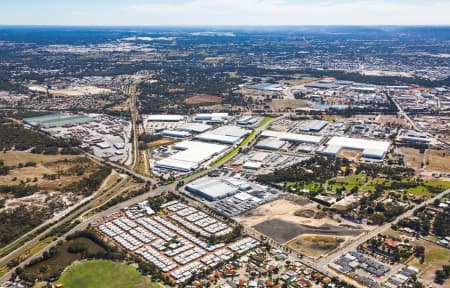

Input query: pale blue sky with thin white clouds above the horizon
[0,0,450,26]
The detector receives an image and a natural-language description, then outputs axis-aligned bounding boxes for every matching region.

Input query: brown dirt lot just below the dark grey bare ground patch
[287,235,345,257]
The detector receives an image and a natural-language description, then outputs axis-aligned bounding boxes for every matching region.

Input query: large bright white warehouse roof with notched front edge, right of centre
[323,137,391,159]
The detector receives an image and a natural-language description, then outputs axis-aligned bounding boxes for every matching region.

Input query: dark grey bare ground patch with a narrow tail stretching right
[253,219,362,243]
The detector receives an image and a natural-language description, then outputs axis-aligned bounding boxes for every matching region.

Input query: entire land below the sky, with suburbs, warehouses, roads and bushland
[0,23,450,288]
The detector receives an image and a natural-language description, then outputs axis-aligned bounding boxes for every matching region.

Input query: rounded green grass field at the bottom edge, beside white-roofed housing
[58,260,154,288]
